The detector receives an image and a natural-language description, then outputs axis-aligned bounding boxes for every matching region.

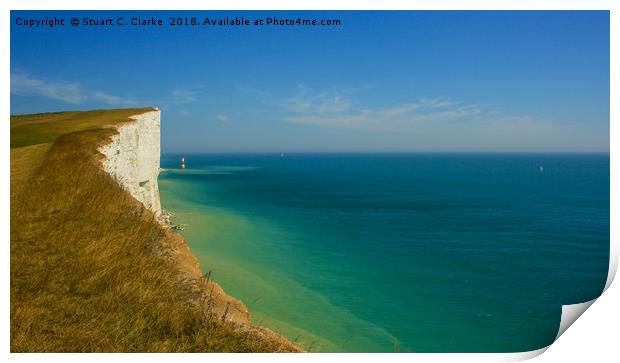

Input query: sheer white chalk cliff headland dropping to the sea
[99,109,161,217]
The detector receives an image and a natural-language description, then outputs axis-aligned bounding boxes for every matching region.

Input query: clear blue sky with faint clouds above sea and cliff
[11,11,609,153]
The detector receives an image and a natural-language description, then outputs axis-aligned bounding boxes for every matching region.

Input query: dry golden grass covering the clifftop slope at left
[11,109,300,352]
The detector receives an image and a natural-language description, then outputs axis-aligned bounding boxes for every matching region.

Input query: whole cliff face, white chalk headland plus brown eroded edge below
[93,109,302,352]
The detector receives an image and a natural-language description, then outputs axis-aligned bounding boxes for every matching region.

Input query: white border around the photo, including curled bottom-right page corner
[0,0,620,362]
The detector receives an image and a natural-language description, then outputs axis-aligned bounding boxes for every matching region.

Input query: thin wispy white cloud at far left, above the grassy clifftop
[11,71,136,106]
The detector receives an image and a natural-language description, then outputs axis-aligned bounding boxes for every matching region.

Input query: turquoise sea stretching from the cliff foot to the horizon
[159,153,609,352]
